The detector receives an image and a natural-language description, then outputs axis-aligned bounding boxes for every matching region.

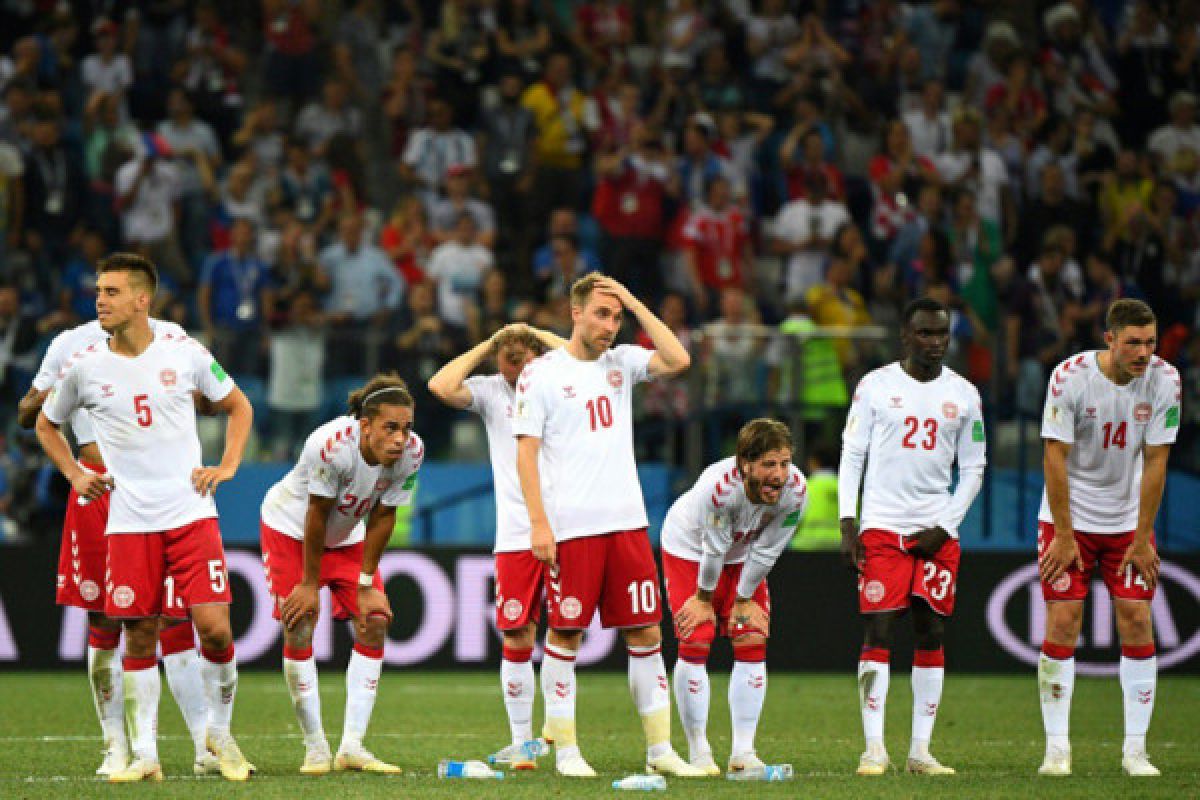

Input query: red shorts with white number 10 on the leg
[546,528,662,631]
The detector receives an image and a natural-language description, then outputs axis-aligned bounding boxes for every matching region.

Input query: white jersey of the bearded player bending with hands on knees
[662,457,809,597]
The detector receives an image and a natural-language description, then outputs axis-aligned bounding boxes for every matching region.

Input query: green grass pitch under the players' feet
[0,669,1200,800]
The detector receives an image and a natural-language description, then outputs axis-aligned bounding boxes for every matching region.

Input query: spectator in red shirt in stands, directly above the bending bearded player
[682,175,754,309]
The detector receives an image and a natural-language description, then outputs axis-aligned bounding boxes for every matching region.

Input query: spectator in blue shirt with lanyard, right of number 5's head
[196,217,270,374]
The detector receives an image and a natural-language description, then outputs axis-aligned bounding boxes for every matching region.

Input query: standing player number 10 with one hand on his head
[512,273,704,777]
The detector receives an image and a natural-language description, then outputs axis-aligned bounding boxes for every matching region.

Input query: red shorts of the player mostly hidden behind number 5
[54,462,110,612]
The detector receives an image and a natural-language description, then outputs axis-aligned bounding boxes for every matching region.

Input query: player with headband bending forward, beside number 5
[260,373,425,775]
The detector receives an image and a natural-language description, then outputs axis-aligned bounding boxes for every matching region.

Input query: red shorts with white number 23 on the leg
[858,528,962,616]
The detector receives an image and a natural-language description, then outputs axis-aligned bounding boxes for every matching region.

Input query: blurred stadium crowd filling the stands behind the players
[0,0,1200,501]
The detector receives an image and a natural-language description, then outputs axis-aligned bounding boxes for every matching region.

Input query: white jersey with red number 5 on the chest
[42,330,234,534]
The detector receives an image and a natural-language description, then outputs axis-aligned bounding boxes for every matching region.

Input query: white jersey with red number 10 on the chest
[512,344,654,542]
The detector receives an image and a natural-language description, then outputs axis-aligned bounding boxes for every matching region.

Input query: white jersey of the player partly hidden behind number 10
[463,374,530,553]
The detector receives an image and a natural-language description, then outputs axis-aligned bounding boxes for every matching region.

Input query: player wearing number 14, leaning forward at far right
[1038,299,1181,777]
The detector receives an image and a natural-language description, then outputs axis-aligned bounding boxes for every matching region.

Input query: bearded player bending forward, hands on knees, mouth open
[662,419,808,775]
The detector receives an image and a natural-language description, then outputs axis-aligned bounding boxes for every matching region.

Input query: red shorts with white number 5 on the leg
[104,517,230,618]
